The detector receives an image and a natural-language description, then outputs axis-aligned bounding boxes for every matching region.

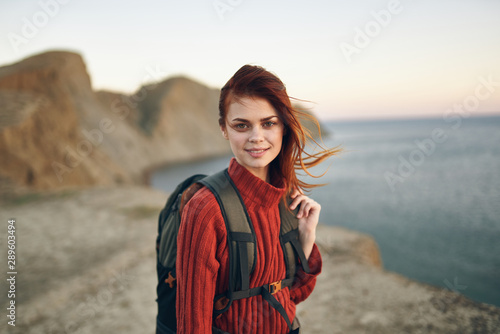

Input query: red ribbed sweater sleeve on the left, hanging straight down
[176,189,224,334]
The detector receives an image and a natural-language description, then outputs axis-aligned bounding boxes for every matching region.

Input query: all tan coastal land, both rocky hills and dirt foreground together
[0,51,500,334]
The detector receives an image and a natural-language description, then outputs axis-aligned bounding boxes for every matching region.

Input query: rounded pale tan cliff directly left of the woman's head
[138,77,230,163]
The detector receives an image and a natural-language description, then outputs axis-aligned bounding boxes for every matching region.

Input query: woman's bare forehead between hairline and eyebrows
[227,97,279,121]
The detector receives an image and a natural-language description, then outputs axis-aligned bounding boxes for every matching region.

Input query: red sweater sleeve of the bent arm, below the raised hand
[290,244,323,304]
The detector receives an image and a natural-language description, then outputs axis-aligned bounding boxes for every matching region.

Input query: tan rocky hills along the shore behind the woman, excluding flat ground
[0,51,330,191]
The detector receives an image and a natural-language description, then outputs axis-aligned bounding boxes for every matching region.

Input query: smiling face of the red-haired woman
[221,97,284,182]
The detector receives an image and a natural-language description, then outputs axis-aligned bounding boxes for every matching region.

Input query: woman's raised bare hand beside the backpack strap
[290,190,321,259]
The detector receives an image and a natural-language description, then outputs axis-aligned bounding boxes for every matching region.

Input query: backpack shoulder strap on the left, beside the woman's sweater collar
[199,169,257,298]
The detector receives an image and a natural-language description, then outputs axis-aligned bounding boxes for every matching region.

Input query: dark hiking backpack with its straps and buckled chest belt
[156,169,310,334]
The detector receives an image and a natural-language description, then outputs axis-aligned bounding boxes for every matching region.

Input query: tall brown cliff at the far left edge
[0,52,126,189]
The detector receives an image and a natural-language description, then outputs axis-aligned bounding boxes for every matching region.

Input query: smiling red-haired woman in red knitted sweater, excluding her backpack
[176,65,338,333]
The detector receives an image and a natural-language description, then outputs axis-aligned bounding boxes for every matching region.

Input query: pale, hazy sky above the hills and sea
[0,0,500,120]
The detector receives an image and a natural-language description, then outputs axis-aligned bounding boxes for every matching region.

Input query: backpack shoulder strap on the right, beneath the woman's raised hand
[279,198,310,276]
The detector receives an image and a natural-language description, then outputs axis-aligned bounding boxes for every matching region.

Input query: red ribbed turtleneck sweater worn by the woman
[176,158,322,334]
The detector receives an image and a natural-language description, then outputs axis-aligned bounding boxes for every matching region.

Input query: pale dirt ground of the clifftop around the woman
[0,187,500,334]
